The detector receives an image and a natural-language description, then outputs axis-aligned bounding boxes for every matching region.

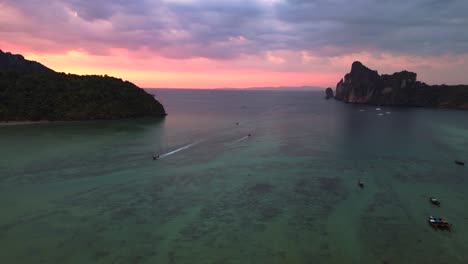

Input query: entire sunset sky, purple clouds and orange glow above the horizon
[0,0,468,88]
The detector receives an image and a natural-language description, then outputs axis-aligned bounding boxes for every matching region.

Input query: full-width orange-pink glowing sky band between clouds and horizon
[0,41,468,88]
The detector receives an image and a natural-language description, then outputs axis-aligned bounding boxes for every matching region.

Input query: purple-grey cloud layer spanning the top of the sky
[0,0,468,59]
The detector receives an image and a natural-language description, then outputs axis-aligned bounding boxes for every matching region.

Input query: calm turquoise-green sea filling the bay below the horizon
[0,90,468,264]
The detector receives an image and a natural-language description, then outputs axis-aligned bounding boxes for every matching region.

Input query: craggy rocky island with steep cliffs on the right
[335,61,468,110]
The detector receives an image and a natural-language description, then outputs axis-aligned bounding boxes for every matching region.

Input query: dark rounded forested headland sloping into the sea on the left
[0,50,166,122]
